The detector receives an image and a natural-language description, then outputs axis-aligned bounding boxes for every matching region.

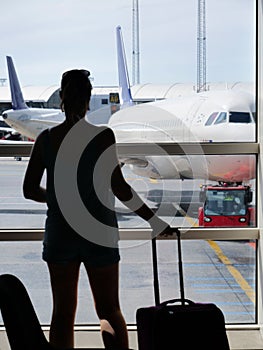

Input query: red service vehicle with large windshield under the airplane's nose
[198,183,255,227]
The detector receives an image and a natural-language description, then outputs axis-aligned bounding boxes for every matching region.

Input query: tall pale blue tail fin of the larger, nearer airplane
[116,26,133,106]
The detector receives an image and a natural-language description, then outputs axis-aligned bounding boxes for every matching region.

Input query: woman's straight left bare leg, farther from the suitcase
[48,262,80,349]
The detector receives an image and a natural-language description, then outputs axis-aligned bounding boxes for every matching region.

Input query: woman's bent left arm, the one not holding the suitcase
[23,134,46,203]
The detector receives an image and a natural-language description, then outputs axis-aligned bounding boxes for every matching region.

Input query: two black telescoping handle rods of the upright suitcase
[152,228,186,305]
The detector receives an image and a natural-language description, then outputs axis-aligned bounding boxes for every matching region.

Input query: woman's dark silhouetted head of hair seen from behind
[60,69,92,125]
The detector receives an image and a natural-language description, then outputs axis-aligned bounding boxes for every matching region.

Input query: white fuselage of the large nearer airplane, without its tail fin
[109,90,255,182]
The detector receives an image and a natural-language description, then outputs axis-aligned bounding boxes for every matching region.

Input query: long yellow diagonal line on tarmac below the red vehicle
[207,240,255,304]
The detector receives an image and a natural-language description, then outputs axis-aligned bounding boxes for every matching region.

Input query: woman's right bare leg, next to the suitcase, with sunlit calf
[86,263,129,349]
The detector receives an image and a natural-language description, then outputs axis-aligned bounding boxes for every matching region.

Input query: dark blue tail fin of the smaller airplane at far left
[6,56,28,110]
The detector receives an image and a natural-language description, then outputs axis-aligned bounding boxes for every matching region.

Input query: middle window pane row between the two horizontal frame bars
[0,155,256,229]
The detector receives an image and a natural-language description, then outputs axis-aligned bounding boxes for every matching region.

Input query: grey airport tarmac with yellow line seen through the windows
[0,158,256,325]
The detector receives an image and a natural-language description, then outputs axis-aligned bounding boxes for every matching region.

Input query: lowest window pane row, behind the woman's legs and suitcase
[0,239,256,325]
